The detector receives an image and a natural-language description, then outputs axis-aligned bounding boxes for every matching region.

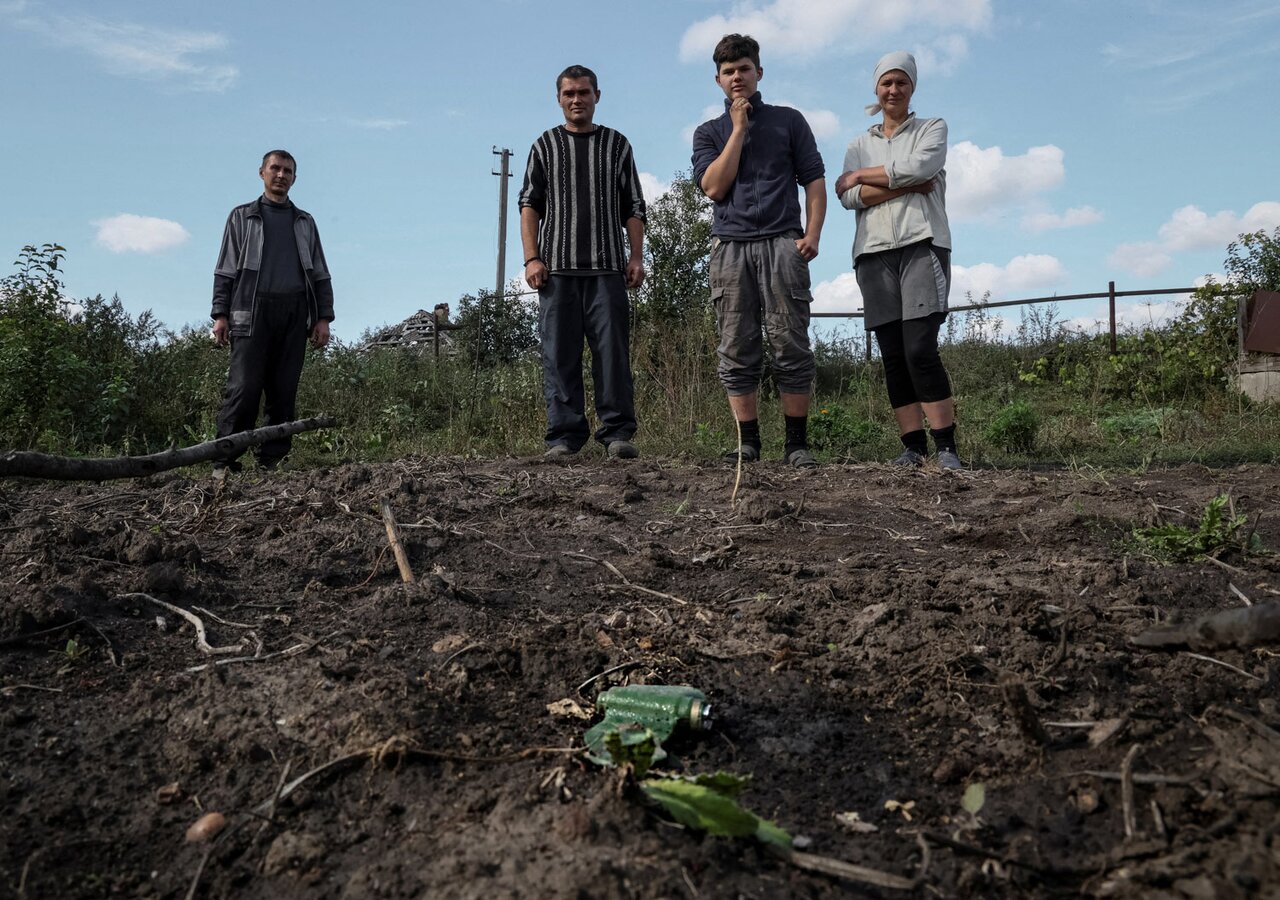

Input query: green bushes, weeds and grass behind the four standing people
[0,200,1280,466]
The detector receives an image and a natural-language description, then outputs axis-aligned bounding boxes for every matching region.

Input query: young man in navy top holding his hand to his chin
[694,35,827,469]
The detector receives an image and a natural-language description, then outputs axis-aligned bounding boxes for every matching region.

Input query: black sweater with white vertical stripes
[520,125,645,273]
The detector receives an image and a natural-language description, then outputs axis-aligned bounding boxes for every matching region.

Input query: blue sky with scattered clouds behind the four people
[0,0,1280,341]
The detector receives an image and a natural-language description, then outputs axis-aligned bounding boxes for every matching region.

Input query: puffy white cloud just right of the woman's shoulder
[947,141,1066,221]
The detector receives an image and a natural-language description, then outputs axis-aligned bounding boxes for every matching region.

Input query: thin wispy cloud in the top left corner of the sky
[17,15,239,91]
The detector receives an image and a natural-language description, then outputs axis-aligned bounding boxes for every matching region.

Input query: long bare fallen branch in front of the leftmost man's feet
[0,416,337,481]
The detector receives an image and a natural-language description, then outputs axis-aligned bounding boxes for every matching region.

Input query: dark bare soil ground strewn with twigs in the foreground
[0,456,1280,900]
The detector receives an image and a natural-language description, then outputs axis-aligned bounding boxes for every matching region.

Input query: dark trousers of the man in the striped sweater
[538,274,636,451]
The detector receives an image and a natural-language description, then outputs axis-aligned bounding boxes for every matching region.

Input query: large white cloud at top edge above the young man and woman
[680,0,992,64]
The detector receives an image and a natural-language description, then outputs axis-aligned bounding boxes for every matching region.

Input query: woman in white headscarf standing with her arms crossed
[836,50,964,469]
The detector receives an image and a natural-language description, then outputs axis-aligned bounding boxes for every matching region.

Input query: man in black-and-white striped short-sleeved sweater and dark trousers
[520,65,645,460]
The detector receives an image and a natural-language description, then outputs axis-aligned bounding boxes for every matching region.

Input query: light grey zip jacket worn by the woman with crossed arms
[840,113,951,268]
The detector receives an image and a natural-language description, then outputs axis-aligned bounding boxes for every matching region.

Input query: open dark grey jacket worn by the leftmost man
[209,197,333,338]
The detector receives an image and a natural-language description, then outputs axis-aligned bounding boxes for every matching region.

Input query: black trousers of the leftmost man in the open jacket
[218,293,307,466]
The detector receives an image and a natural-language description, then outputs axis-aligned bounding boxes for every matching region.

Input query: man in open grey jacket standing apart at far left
[210,150,333,476]
